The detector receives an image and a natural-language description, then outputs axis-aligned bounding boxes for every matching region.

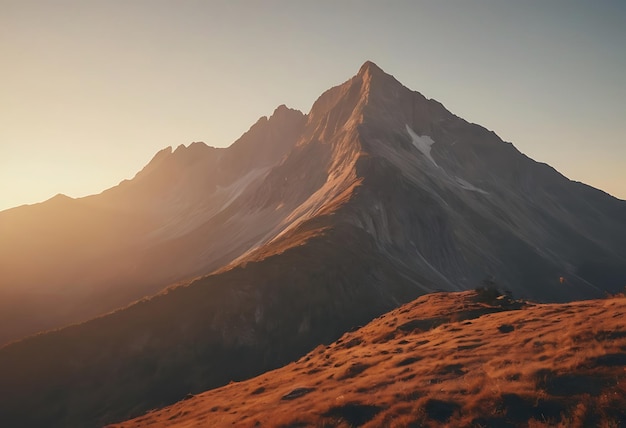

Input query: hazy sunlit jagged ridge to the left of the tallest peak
[0,106,305,344]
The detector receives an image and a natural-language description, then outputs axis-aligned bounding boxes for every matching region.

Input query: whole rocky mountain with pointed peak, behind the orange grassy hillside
[0,62,626,427]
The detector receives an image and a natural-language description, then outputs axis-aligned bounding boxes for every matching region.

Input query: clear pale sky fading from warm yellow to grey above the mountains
[0,0,626,210]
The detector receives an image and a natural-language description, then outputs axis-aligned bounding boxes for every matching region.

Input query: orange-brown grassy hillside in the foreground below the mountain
[111,289,626,428]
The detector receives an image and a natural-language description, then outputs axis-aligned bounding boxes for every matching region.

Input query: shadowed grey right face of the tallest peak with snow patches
[336,63,626,301]
